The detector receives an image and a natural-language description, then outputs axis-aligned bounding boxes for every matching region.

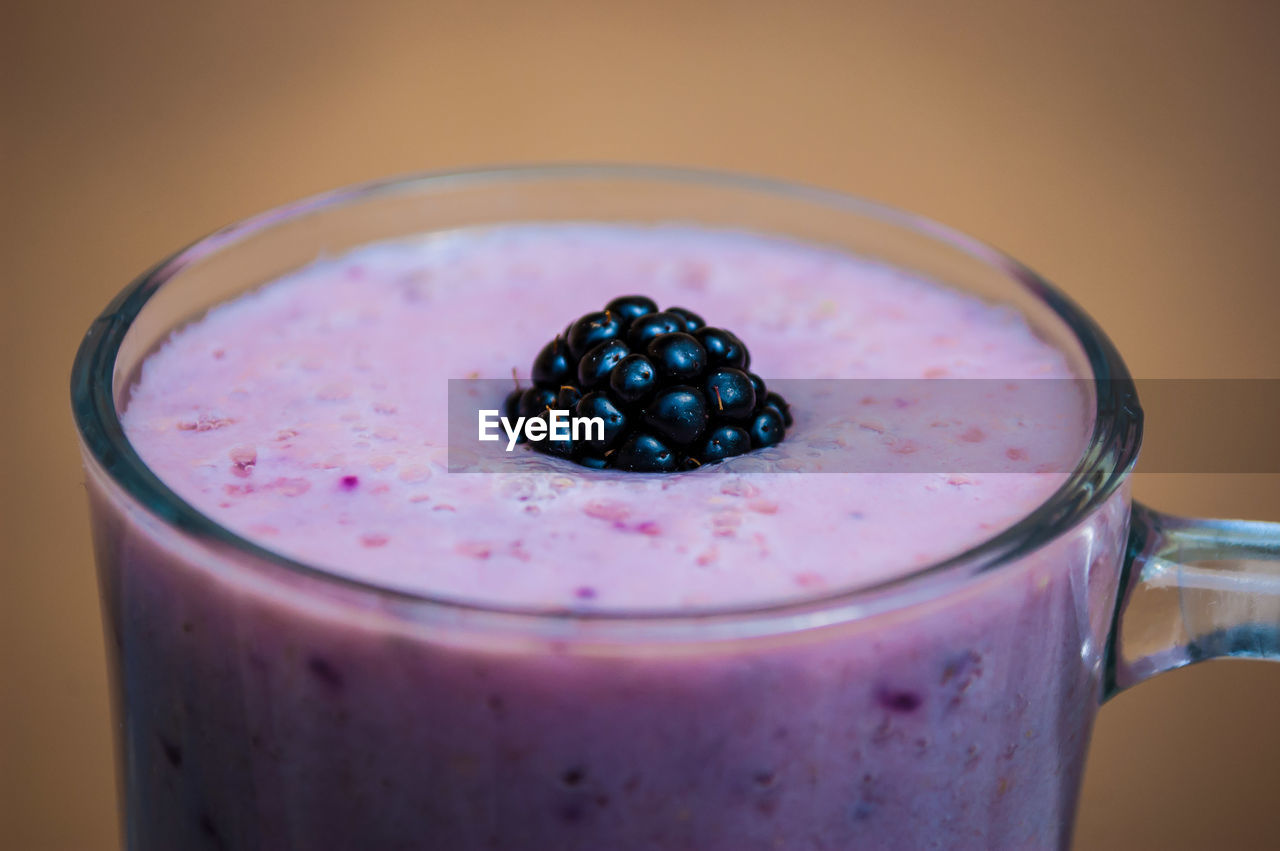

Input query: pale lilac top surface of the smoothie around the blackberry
[124,225,1088,609]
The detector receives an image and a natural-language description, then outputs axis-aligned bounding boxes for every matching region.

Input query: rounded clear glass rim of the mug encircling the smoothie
[70,163,1142,637]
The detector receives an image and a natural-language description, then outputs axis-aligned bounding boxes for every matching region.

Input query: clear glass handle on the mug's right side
[1103,503,1280,699]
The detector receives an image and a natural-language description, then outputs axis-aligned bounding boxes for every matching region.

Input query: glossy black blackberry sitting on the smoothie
[512,296,791,472]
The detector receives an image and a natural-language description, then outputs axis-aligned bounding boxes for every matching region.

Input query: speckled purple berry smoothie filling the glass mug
[91,227,1124,851]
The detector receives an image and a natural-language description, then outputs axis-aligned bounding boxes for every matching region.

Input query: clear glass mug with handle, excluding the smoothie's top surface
[72,166,1280,851]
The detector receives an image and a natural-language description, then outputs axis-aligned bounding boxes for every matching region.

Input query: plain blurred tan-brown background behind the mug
[0,0,1280,851]
